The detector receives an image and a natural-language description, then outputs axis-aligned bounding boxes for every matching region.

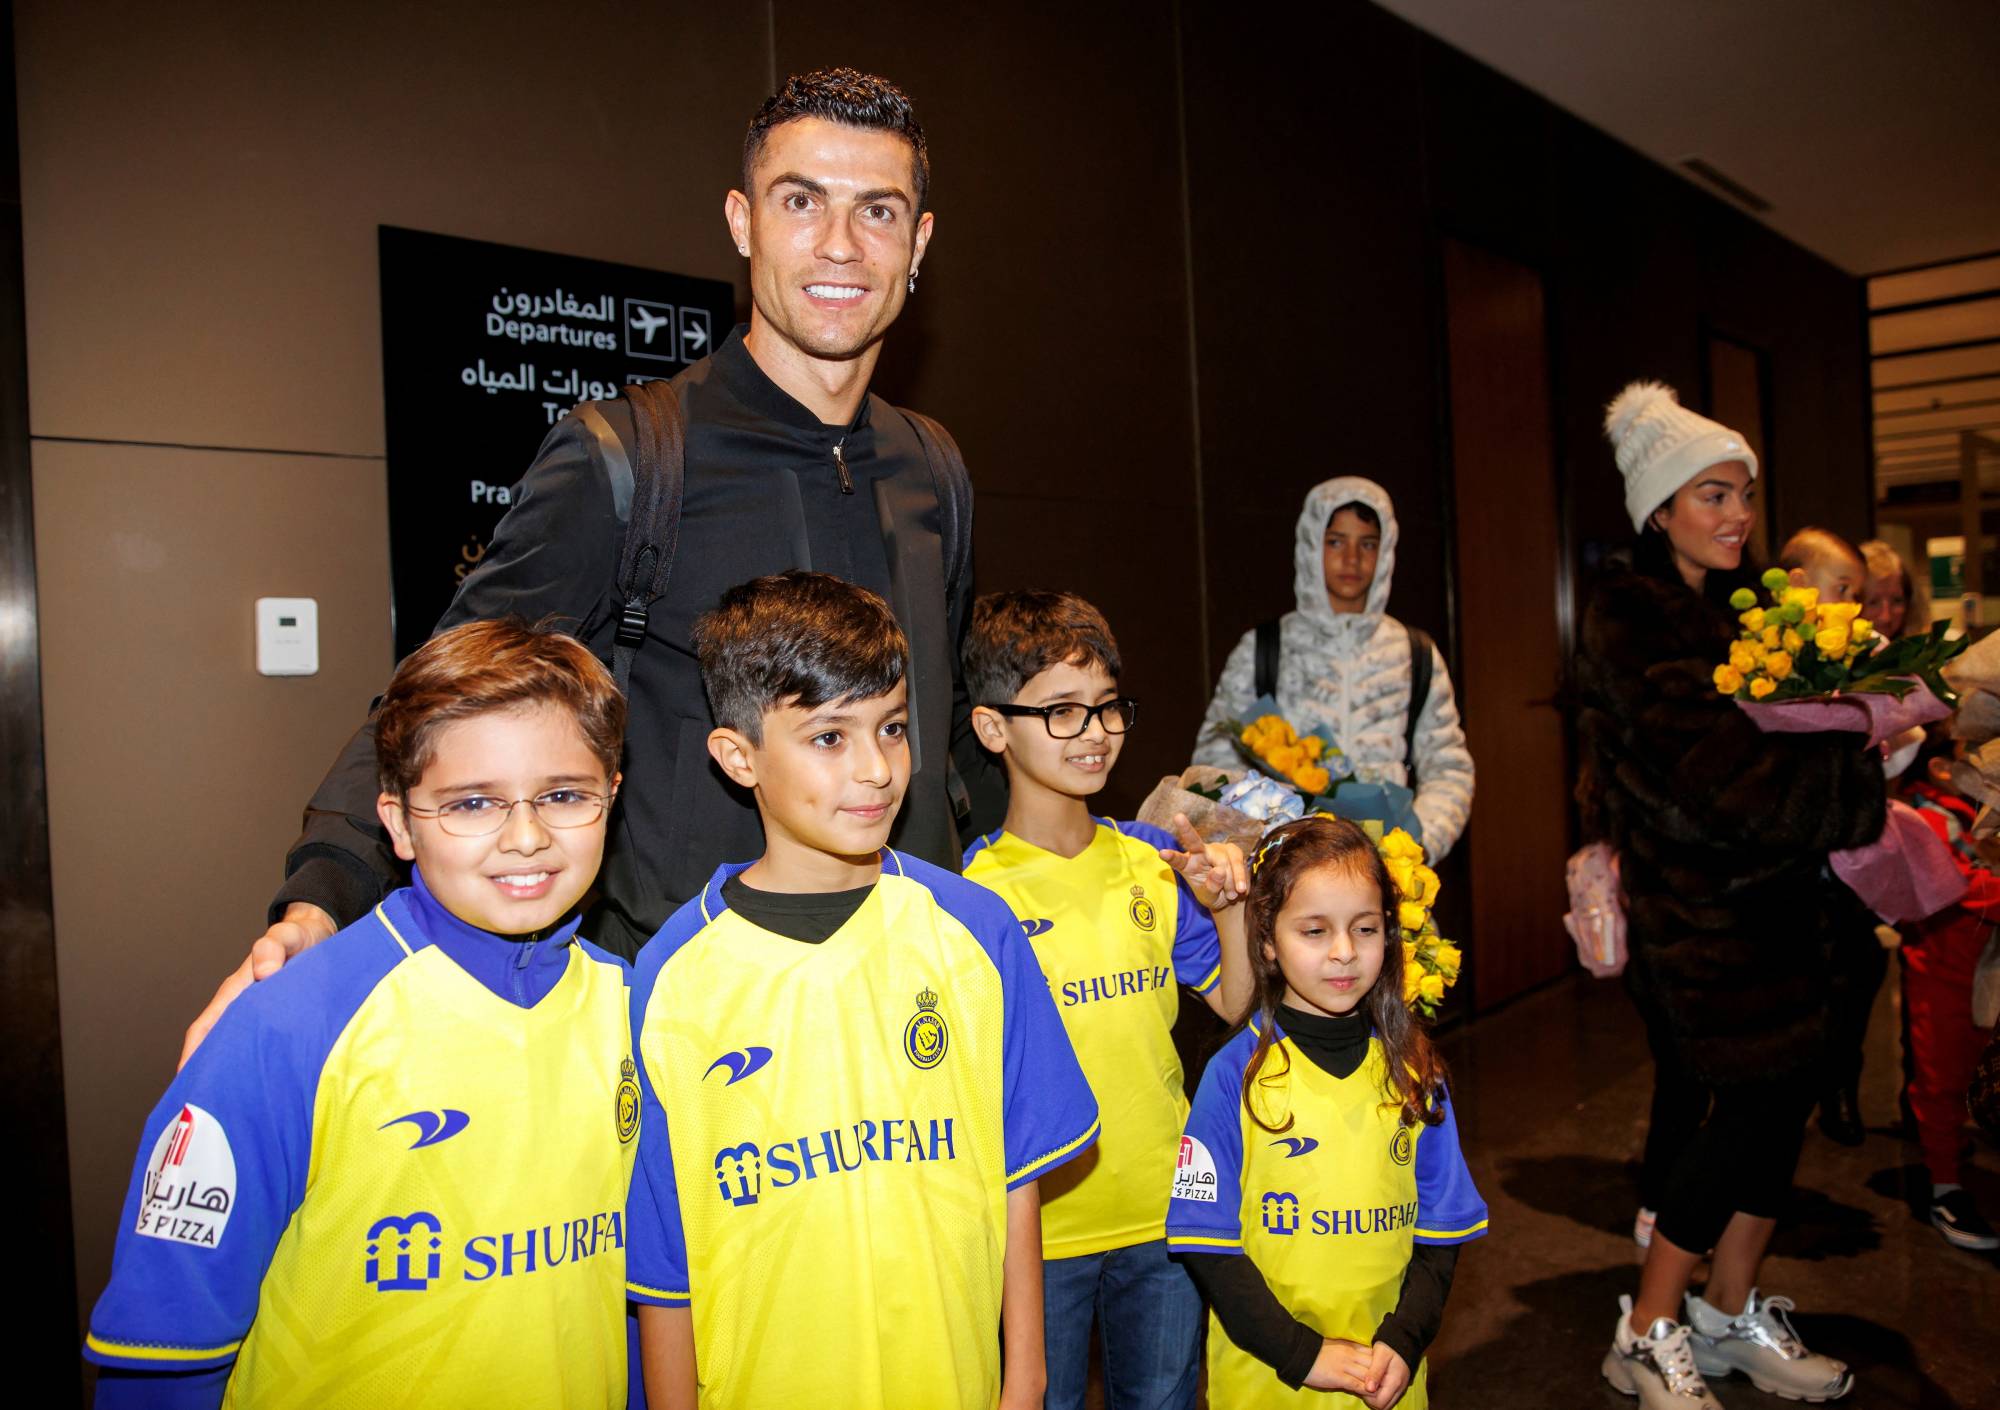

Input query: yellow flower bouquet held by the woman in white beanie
[1714,568,1964,706]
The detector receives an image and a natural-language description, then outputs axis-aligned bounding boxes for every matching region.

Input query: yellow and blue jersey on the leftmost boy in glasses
[86,890,638,1410]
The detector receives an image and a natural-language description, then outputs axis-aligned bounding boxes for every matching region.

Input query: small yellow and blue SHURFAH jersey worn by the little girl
[1166,1028,1486,1410]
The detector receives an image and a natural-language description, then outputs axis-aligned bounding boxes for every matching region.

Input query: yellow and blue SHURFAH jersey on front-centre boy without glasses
[628,852,1098,1410]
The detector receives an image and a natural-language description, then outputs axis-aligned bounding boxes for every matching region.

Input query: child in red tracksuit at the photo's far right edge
[1902,748,2000,1248]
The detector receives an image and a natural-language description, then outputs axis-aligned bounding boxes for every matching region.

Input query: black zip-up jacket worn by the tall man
[270,326,1004,956]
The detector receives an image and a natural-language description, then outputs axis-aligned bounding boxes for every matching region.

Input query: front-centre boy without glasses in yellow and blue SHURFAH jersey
[628,572,1098,1410]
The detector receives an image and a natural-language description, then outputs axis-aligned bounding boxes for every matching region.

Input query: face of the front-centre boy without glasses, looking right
[708,682,910,890]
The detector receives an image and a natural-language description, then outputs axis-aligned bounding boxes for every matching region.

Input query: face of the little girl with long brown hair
[1264,862,1388,1014]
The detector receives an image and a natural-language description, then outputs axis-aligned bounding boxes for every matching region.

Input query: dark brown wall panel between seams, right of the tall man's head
[774,0,1210,810]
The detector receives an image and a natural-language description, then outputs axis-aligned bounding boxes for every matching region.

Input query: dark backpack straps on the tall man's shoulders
[612,380,972,690]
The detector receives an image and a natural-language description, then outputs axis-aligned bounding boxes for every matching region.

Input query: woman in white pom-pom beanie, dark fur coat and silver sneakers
[1576,382,1884,1410]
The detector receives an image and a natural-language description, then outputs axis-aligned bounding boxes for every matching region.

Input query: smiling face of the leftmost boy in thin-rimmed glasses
[376,706,618,936]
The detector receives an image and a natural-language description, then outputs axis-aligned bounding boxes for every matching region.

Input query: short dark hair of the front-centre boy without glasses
[694,568,910,744]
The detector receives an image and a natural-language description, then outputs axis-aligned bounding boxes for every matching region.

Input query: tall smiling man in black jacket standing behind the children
[182,70,1004,1060]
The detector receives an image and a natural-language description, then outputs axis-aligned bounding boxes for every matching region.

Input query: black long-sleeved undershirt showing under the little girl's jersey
[1180,1004,1458,1390]
